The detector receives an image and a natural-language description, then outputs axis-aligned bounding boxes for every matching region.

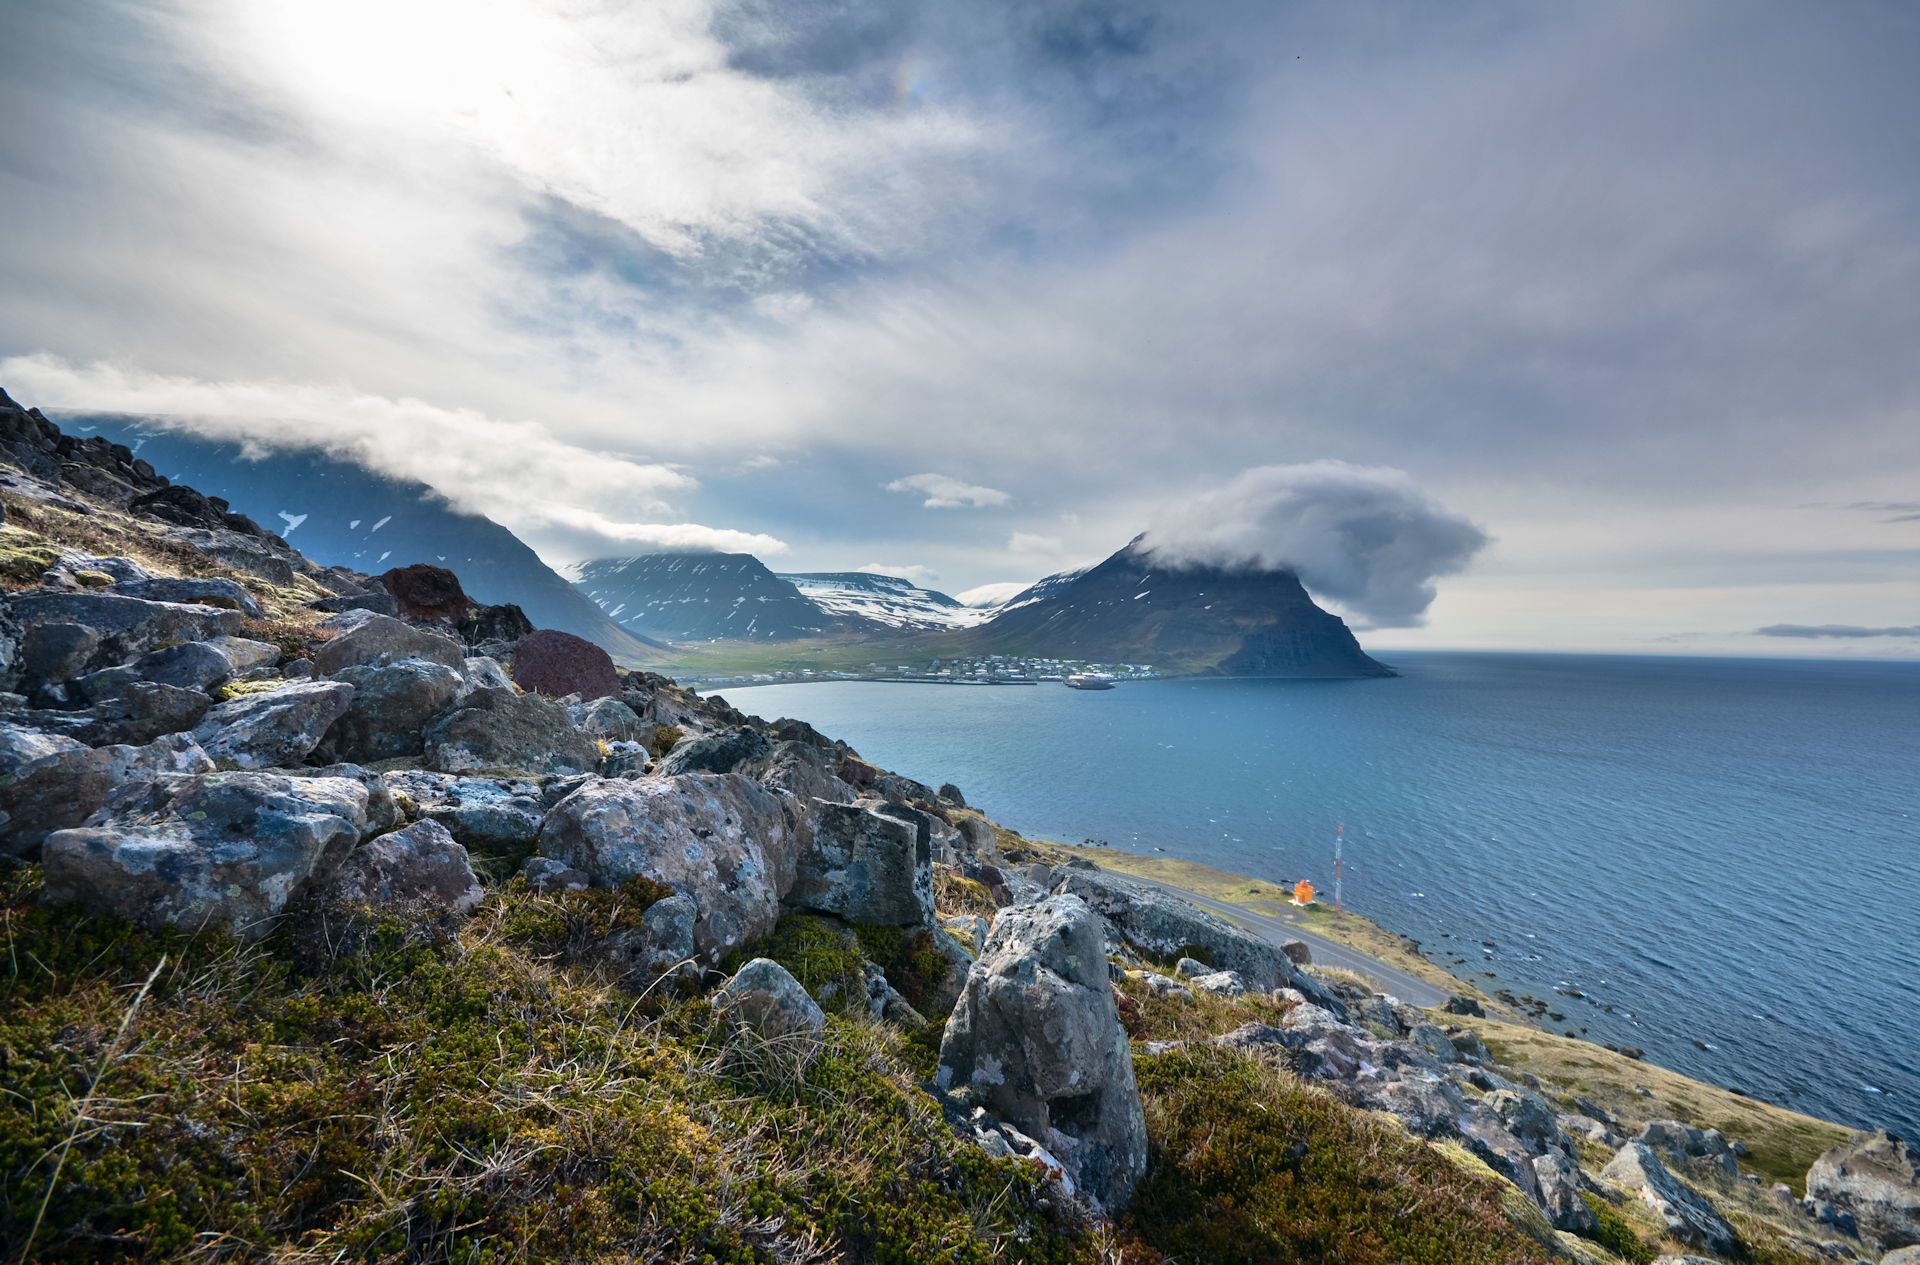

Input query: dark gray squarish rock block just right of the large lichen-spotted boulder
[785,804,939,927]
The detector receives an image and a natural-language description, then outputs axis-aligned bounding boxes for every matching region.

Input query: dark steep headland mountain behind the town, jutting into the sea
[970,537,1394,678]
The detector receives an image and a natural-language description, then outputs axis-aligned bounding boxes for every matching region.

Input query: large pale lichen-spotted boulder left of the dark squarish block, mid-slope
[540,774,793,964]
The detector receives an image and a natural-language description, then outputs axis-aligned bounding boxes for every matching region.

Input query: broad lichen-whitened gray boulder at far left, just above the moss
[42,774,367,939]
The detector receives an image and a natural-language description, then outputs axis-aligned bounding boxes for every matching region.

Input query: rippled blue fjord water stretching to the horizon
[726,653,1920,1136]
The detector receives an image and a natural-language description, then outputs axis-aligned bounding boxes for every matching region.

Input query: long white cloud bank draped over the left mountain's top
[0,353,785,553]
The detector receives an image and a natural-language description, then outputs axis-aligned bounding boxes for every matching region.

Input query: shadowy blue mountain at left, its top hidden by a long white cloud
[61,415,660,662]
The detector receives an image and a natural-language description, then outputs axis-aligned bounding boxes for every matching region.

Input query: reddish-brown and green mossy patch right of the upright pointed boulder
[1123,1046,1549,1265]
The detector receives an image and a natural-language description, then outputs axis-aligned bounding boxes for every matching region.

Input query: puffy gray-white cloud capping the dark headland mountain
[1144,461,1488,628]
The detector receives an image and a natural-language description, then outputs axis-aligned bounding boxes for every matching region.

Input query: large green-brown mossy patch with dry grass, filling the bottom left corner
[0,868,1094,1263]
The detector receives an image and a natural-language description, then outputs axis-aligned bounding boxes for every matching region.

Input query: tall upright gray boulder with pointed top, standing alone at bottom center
[939,896,1146,1211]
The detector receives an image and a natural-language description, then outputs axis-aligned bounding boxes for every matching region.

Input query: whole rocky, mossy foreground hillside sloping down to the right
[0,391,1920,1265]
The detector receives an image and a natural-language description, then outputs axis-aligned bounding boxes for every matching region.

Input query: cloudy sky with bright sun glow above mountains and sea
[0,0,1920,656]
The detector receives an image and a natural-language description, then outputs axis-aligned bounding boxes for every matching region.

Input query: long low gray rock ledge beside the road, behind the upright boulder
[1054,868,1346,1015]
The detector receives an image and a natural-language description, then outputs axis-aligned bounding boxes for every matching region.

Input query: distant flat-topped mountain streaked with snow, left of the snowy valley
[574,553,837,641]
